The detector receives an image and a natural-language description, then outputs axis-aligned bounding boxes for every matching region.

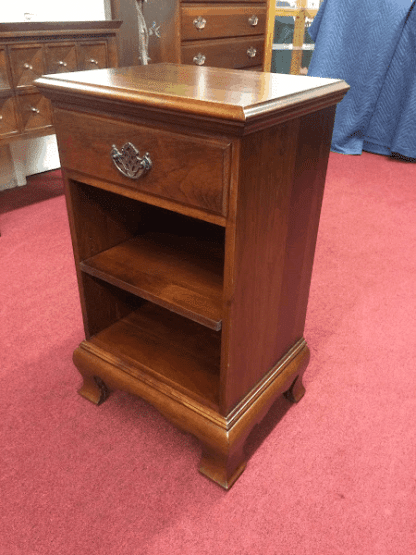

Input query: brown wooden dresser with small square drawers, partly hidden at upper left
[0,21,121,142]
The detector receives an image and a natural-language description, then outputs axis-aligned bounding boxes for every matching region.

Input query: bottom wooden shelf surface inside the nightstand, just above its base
[89,302,221,410]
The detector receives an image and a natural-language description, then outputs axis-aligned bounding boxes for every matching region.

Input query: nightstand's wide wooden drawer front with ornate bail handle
[54,109,231,215]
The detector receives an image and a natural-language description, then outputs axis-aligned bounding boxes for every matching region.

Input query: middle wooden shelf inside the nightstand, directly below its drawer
[80,232,224,331]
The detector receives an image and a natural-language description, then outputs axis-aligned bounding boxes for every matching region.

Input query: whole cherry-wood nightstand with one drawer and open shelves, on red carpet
[36,64,348,488]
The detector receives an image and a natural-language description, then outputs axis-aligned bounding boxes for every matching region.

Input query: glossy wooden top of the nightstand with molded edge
[36,64,349,132]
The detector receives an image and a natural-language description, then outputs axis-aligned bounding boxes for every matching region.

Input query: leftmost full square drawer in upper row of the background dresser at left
[10,46,46,88]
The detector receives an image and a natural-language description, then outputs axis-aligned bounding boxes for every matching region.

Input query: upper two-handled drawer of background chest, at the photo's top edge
[181,5,266,40]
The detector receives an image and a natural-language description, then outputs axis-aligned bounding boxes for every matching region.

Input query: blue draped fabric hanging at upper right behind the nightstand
[308,0,416,158]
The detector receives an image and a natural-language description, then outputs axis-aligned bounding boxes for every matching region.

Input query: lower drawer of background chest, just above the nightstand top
[182,37,264,69]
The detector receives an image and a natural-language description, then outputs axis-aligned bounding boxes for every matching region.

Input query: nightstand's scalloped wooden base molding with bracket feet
[73,338,310,489]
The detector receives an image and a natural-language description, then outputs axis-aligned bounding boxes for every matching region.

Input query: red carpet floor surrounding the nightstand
[0,153,416,555]
